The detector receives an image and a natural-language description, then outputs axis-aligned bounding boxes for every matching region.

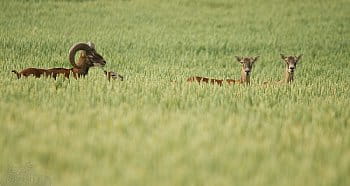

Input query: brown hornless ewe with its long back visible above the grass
[187,56,259,86]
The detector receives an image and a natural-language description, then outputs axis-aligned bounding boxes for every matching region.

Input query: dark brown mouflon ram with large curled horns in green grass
[12,42,106,79]
